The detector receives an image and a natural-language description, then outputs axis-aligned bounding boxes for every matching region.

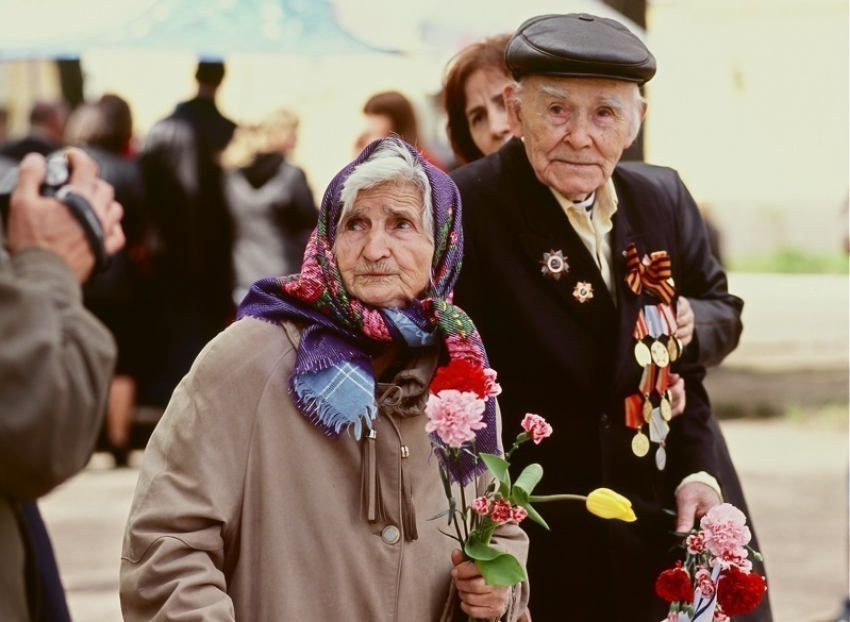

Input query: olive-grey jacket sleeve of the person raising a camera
[0,249,116,500]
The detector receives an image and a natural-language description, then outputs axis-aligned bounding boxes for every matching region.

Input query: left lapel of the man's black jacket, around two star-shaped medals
[504,141,616,336]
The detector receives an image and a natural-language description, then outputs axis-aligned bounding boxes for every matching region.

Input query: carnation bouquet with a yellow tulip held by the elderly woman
[425,359,636,586]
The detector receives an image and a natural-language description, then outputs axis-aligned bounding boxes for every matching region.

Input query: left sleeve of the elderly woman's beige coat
[120,332,255,622]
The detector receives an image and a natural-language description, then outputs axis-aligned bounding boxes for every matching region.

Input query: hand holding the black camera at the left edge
[8,149,124,283]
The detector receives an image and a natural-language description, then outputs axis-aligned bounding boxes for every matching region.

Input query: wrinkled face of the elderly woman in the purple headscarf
[334,184,434,307]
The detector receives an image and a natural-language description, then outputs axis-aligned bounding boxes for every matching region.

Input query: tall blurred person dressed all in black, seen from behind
[140,61,236,405]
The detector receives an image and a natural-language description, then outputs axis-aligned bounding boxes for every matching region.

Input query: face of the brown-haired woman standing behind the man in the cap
[464,67,511,155]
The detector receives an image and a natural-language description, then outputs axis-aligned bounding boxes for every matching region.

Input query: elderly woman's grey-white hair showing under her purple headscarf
[339,140,434,244]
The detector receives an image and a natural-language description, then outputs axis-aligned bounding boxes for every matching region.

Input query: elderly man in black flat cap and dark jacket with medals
[453,14,768,622]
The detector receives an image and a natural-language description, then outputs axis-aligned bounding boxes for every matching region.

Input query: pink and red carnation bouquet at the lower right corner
[655,503,767,622]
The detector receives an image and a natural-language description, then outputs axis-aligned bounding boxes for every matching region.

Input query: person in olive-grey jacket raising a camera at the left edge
[0,150,124,622]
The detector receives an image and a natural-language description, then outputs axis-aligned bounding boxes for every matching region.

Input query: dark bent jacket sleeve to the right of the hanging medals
[667,174,744,367]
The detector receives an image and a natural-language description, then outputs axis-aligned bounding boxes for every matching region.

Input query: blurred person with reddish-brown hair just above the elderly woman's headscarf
[354,91,446,170]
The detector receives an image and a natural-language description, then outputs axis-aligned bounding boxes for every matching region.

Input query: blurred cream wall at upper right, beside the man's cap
[646,0,850,255]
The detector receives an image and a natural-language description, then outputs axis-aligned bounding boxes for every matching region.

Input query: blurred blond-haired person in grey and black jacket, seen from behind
[222,110,318,304]
